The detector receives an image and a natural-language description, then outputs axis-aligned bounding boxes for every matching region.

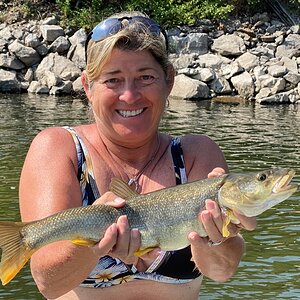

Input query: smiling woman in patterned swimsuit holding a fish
[20,13,255,300]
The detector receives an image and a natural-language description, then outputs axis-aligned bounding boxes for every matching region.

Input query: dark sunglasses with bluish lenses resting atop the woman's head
[85,16,169,62]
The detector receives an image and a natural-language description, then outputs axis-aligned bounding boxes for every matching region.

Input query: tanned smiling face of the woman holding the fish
[87,49,174,143]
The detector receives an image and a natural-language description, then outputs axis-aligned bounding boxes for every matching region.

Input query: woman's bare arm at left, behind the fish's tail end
[20,128,123,298]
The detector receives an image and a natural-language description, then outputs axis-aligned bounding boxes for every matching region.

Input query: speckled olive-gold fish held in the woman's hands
[0,168,298,285]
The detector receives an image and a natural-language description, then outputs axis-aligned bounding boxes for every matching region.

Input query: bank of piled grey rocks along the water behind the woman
[0,13,300,104]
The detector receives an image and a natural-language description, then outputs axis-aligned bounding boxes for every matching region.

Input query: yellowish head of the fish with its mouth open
[218,168,298,217]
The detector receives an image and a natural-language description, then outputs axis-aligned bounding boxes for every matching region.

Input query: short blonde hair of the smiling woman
[86,12,169,83]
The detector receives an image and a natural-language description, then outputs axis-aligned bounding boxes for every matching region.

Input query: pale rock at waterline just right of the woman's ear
[170,74,209,99]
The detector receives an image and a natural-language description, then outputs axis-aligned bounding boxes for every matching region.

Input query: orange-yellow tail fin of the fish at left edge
[0,222,37,285]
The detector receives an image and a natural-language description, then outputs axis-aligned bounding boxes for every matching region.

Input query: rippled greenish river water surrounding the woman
[0,94,300,300]
